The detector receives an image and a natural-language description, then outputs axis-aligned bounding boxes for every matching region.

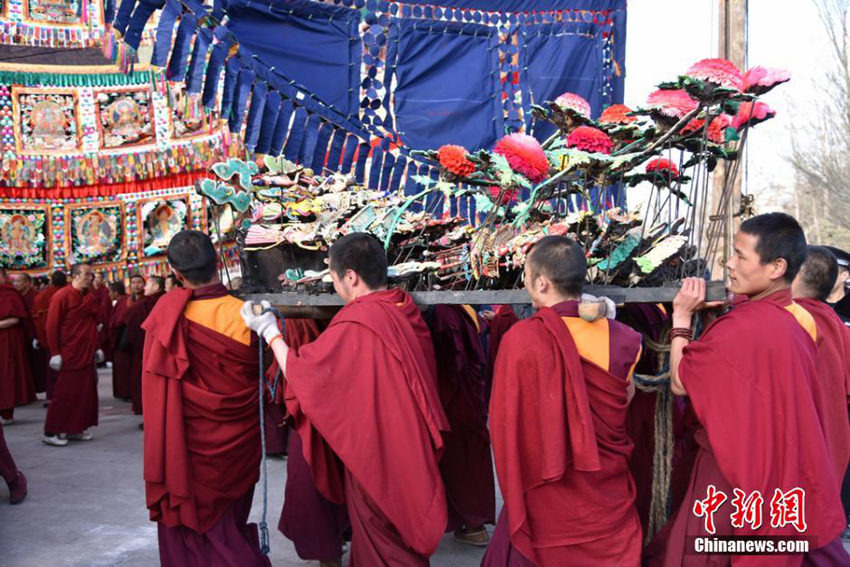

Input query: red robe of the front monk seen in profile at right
[646,289,845,567]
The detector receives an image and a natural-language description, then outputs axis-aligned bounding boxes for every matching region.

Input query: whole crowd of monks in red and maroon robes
[0,213,850,567]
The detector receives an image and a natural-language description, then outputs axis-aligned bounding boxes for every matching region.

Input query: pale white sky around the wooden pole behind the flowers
[625,0,829,212]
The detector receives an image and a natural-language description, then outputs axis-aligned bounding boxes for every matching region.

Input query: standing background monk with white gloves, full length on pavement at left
[42,264,104,447]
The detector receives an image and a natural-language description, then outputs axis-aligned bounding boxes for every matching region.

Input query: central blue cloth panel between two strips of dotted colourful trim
[387,19,504,150]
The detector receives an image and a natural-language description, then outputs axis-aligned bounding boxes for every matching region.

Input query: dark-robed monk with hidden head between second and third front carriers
[428,305,496,546]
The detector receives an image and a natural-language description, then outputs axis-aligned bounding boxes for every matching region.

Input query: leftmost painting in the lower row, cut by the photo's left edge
[0,205,50,270]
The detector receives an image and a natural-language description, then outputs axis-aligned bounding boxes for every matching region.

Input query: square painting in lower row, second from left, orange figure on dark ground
[65,202,124,264]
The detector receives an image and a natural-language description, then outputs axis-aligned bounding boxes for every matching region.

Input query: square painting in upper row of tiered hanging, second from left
[96,89,155,150]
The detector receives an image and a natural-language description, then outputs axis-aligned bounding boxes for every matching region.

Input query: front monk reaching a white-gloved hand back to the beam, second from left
[242,233,448,567]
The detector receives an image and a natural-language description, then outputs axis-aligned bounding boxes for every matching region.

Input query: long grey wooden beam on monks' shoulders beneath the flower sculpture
[243,282,726,308]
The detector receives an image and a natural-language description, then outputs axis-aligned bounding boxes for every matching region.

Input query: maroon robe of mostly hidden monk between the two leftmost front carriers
[271,319,351,561]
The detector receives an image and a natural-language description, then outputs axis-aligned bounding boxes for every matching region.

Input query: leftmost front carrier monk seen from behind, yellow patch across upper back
[142,230,271,567]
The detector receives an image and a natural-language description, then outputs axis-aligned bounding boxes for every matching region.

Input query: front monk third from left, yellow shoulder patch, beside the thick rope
[482,236,641,567]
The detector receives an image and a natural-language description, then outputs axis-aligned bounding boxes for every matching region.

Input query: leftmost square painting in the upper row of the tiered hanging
[12,88,81,154]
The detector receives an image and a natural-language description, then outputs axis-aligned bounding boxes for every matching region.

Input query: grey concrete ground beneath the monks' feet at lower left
[0,371,490,567]
